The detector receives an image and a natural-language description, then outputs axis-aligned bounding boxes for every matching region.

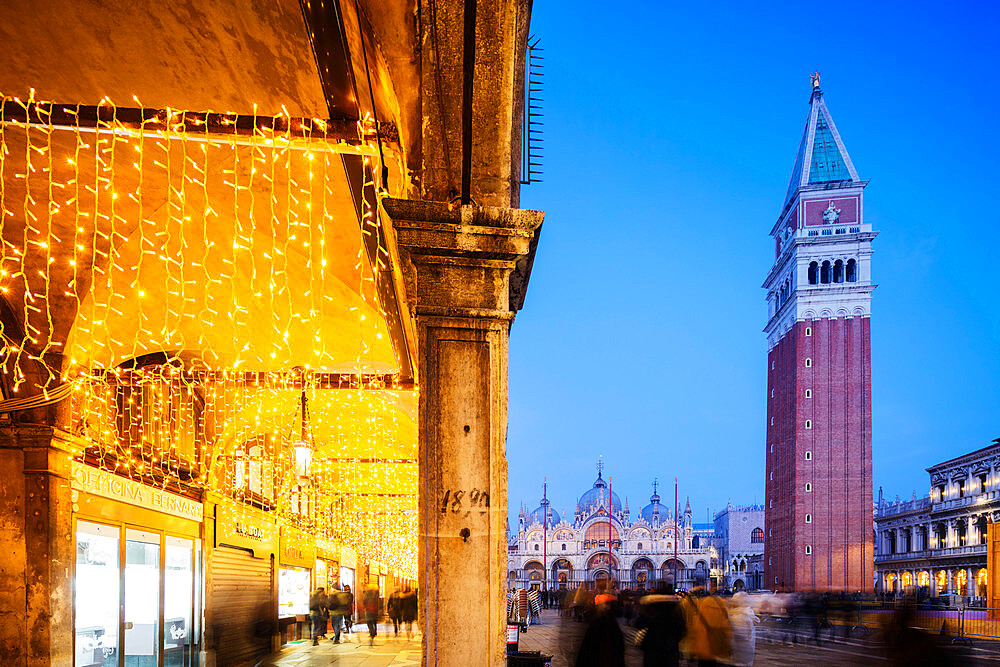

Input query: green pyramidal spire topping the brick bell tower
[782,72,861,210]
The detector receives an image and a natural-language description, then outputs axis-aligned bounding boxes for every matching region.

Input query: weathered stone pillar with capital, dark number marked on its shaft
[383,199,543,667]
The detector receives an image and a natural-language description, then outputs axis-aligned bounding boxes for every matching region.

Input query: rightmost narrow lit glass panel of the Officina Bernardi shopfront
[163,535,195,667]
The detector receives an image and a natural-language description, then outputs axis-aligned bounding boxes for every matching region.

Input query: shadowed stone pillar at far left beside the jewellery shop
[0,424,76,665]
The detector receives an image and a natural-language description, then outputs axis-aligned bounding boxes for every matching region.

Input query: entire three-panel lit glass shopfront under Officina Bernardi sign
[74,519,201,667]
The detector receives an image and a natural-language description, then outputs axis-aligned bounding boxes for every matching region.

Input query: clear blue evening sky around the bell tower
[507,0,1000,522]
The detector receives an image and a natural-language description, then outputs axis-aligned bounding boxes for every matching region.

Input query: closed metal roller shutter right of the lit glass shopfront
[211,547,276,667]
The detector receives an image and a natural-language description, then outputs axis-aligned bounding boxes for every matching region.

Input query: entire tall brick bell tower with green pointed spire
[763,74,877,592]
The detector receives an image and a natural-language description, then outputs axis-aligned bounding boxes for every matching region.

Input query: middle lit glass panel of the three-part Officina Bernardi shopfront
[125,528,160,667]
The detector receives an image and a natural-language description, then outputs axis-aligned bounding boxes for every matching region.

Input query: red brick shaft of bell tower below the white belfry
[764,317,873,591]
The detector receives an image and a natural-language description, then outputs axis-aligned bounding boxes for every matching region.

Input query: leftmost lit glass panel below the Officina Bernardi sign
[74,521,120,667]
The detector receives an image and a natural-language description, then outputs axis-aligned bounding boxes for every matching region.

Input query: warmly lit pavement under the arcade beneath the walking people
[265,624,420,667]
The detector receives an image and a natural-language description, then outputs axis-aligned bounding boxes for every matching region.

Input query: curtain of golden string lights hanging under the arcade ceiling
[0,94,417,578]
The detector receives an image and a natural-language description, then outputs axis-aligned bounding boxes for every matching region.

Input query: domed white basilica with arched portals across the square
[507,464,719,590]
